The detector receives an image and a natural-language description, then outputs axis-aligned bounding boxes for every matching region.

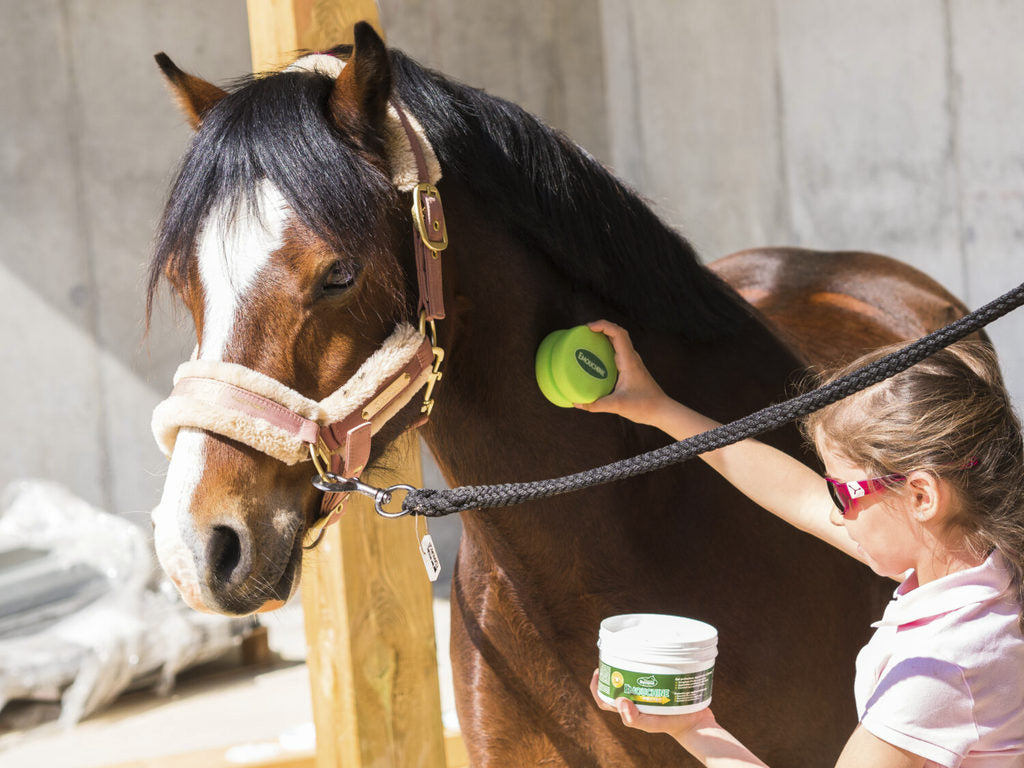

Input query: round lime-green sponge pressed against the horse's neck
[535,326,618,408]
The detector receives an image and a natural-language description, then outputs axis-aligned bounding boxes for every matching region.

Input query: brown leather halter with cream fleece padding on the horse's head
[153,53,447,546]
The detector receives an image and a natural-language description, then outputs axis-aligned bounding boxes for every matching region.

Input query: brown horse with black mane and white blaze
[151,25,961,768]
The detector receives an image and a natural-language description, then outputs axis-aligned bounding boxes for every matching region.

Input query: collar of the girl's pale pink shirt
[871,550,1011,627]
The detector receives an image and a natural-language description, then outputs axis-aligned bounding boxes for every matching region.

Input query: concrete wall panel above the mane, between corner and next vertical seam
[602,0,787,256]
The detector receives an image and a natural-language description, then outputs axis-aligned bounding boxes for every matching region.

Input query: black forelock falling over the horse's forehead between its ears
[147,72,395,325]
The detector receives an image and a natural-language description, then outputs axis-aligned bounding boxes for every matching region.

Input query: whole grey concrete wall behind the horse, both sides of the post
[0,0,1024,528]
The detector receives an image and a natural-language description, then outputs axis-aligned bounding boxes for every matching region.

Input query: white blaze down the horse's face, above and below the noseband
[153,181,289,609]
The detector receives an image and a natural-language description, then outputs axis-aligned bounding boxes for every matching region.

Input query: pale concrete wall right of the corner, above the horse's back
[601,0,1024,404]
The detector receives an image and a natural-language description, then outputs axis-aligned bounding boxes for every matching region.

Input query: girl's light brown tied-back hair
[803,341,1024,631]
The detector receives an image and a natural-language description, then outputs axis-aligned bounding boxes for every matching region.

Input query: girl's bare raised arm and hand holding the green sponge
[577,321,863,562]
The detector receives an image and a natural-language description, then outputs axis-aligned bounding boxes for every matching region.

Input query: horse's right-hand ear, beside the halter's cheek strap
[331,22,391,127]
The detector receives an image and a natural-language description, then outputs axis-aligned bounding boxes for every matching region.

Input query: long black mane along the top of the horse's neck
[391,50,749,339]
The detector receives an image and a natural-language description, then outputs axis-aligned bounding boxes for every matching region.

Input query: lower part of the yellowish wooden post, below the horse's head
[302,440,445,768]
